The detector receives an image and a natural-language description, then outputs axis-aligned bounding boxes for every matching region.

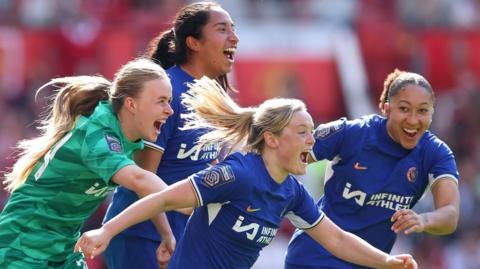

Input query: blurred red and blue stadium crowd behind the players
[0,0,480,269]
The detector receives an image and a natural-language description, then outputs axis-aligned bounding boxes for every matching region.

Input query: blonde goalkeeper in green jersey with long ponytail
[0,59,175,269]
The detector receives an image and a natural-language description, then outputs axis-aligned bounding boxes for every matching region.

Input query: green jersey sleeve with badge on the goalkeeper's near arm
[81,132,135,184]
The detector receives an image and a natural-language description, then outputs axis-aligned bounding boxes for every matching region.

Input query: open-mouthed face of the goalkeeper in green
[132,78,173,142]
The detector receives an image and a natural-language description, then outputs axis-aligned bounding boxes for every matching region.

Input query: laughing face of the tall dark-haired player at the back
[191,6,239,78]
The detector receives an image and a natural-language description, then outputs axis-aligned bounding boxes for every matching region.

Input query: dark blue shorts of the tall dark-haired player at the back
[103,234,160,269]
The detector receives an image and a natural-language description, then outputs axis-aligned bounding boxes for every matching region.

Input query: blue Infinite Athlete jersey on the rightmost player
[286,115,459,268]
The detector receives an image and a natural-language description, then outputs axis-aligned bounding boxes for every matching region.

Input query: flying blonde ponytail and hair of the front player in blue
[182,77,306,154]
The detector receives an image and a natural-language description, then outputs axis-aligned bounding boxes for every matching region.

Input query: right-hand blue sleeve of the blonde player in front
[285,181,325,229]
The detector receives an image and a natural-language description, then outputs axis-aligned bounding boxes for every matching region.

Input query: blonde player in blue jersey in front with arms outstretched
[75,78,416,269]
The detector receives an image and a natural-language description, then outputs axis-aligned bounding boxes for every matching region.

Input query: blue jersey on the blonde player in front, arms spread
[168,153,323,269]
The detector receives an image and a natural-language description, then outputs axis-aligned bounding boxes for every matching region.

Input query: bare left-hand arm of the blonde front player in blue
[75,179,197,258]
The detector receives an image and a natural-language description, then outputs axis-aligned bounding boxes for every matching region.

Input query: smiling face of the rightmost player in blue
[384,84,434,149]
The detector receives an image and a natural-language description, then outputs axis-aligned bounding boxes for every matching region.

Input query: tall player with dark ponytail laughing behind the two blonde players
[104,2,239,269]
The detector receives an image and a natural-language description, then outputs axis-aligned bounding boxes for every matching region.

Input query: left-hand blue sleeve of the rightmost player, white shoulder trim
[312,118,347,161]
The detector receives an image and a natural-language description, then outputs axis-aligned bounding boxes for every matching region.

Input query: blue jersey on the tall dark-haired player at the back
[104,66,220,240]
